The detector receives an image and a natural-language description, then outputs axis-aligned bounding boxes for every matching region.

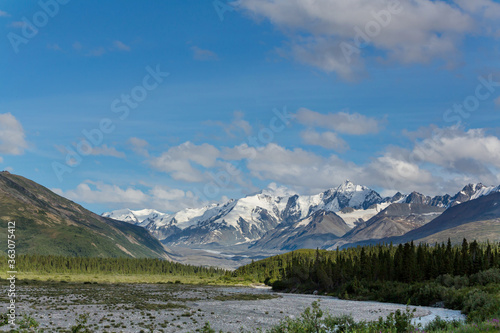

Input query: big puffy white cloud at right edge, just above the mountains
[364,127,500,194]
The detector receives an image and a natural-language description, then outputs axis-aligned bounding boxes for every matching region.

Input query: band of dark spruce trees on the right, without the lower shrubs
[234,240,500,292]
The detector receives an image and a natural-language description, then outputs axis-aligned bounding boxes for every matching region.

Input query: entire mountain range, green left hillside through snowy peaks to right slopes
[0,171,500,268]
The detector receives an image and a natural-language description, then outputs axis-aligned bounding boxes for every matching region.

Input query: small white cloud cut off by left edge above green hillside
[0,113,28,155]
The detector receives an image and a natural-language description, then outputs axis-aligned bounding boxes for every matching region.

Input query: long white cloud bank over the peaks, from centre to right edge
[222,128,500,195]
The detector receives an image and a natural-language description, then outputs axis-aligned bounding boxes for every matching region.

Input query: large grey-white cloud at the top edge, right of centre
[238,0,476,79]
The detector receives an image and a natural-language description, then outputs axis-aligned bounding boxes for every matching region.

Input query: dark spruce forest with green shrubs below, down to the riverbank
[233,239,500,321]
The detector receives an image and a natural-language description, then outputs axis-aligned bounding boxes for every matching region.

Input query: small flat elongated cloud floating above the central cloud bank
[296,108,381,135]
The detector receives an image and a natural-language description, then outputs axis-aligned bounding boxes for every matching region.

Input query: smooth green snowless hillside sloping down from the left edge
[0,171,168,259]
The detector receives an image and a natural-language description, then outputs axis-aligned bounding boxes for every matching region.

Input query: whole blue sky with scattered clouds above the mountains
[0,0,500,213]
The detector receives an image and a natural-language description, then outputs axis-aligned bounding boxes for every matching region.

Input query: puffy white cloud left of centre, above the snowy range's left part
[150,141,220,182]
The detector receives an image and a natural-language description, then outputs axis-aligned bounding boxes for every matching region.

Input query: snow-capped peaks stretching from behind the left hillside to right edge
[103,180,500,249]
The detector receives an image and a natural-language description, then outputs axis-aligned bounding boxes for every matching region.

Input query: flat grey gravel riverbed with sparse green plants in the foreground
[0,281,463,332]
